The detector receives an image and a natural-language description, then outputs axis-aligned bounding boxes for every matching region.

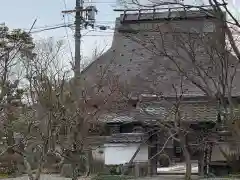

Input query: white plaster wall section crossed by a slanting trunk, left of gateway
[104,143,148,165]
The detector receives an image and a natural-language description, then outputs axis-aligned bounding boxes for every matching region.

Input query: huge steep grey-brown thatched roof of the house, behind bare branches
[83,11,240,96]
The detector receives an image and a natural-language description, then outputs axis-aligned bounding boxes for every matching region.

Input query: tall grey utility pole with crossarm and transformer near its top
[62,0,104,180]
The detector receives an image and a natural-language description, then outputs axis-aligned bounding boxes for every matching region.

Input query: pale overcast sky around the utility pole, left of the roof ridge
[0,0,240,64]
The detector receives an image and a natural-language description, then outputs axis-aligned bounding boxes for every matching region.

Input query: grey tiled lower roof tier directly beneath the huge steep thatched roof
[98,97,217,124]
